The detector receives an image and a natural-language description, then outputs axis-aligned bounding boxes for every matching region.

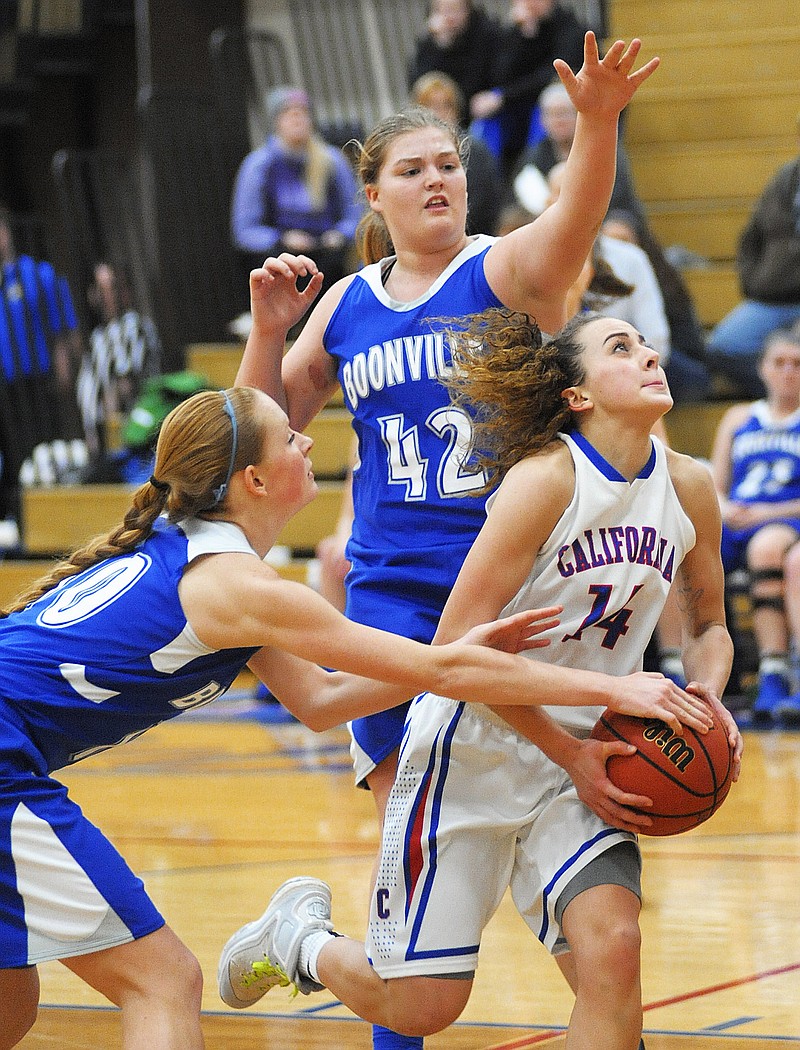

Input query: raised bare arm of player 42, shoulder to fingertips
[485,33,659,332]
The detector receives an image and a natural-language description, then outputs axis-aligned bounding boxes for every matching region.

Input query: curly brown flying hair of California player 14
[442,308,597,491]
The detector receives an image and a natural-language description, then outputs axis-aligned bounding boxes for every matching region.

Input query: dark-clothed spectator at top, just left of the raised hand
[469,0,586,175]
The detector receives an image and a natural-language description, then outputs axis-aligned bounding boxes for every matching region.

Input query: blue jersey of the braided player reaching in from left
[0,519,258,773]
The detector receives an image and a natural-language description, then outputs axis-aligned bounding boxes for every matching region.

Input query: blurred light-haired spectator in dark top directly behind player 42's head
[410,72,504,234]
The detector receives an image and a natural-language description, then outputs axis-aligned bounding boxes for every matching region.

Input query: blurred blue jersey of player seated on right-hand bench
[730,401,800,503]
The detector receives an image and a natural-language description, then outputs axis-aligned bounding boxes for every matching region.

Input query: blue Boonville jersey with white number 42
[324,236,503,551]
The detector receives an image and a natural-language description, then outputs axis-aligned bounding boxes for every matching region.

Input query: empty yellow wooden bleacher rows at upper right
[609,0,800,283]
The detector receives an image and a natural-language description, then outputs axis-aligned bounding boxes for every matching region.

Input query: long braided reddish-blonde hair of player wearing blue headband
[0,386,265,616]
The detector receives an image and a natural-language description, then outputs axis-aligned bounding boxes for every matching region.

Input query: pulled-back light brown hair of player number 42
[344,106,469,265]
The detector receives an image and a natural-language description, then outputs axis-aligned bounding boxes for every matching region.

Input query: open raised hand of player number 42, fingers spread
[553,30,661,121]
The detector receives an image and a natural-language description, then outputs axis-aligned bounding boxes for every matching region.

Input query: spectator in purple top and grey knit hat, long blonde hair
[231,86,361,296]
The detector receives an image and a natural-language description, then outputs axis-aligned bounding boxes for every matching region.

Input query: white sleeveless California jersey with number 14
[488,433,695,735]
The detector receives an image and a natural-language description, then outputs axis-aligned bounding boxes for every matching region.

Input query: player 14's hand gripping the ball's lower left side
[567,738,653,834]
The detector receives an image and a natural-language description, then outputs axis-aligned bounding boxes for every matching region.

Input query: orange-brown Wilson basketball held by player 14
[591,709,733,835]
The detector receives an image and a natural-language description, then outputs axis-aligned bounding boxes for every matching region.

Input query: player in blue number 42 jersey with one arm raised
[237,33,658,1050]
